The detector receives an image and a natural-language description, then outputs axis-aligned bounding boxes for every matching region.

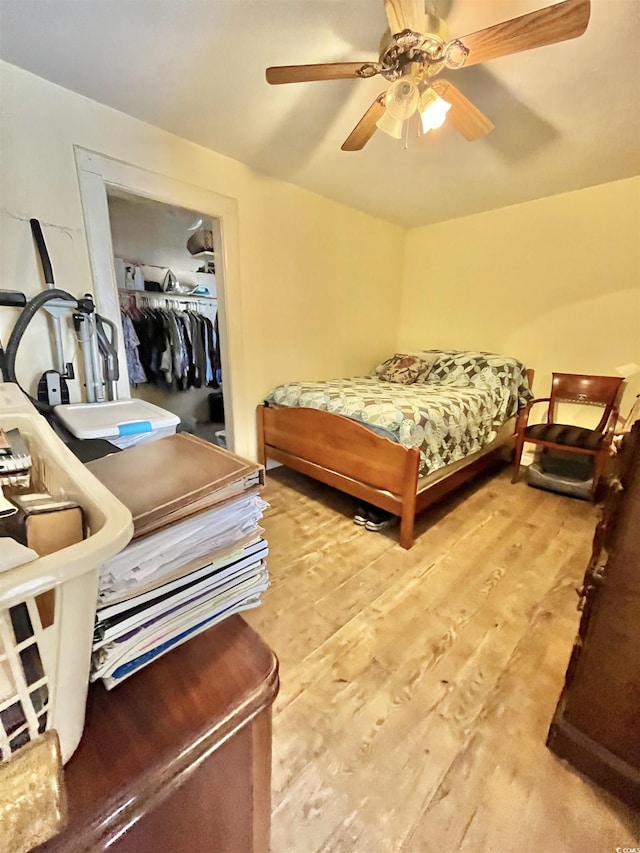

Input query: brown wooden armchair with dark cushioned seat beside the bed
[511,373,624,500]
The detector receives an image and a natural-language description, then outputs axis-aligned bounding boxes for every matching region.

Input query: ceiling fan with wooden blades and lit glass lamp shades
[266,0,591,151]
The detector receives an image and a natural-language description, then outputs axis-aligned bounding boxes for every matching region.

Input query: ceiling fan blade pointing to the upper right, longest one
[460,0,591,68]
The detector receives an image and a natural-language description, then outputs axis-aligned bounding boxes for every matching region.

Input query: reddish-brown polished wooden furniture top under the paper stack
[37,616,278,853]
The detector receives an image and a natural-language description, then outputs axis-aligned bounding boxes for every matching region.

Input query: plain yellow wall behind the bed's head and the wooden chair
[398,178,640,420]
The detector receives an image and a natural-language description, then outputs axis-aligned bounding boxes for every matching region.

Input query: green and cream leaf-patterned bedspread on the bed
[266,350,532,476]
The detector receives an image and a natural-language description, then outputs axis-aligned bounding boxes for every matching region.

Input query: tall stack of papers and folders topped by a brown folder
[88,433,269,689]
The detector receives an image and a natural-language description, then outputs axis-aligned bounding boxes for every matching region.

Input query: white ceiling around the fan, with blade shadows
[0,0,640,226]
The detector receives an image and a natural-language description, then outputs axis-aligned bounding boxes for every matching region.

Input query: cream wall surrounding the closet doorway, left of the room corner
[0,63,405,460]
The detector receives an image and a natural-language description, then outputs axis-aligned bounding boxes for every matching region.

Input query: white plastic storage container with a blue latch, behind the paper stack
[56,400,180,448]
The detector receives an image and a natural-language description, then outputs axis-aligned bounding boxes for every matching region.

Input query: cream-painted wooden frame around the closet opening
[74,146,245,456]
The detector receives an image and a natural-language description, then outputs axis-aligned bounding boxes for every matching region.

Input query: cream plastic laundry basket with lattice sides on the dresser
[0,383,133,762]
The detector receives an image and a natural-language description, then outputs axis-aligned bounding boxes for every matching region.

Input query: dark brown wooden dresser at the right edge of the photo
[547,421,640,809]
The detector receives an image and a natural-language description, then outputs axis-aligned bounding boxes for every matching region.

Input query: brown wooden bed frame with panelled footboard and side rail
[257,370,533,548]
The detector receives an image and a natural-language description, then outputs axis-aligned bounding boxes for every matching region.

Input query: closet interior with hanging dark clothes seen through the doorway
[107,187,229,447]
